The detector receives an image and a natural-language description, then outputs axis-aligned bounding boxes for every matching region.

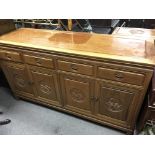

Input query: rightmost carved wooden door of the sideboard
[95,81,140,125]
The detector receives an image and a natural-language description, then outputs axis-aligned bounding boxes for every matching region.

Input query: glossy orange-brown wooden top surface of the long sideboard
[0,28,155,65]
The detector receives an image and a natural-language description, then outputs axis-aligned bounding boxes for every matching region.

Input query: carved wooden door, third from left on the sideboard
[60,74,94,114]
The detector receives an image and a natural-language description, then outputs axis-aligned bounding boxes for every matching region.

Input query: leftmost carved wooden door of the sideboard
[2,62,34,96]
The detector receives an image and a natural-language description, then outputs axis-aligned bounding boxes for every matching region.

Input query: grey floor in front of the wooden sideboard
[0,87,124,135]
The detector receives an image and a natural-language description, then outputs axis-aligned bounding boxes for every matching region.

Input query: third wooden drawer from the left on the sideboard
[58,60,93,75]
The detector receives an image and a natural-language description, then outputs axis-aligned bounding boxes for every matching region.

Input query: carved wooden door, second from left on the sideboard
[30,66,60,105]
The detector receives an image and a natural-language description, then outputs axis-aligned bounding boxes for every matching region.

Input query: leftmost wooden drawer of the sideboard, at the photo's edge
[0,50,22,62]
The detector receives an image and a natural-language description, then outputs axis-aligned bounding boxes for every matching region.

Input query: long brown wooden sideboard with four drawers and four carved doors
[0,28,155,133]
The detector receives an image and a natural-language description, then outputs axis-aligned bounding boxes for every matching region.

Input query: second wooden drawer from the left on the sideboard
[24,55,54,68]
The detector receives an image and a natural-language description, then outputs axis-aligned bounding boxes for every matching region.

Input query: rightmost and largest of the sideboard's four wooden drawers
[97,67,145,86]
